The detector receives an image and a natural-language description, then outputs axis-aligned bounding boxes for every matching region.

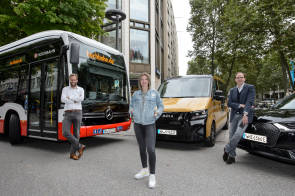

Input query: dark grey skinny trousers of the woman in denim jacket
[134,123,156,174]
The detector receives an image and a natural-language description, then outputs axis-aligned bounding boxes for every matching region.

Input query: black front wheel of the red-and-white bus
[8,114,21,144]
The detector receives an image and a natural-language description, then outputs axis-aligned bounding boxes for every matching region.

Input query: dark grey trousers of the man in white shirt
[62,111,82,154]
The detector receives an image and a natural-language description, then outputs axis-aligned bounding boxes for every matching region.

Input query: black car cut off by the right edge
[238,94,295,163]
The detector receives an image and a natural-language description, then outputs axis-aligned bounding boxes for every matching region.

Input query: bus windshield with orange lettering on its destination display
[73,43,128,104]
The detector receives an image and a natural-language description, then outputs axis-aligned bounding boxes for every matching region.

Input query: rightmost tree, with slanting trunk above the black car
[253,0,295,91]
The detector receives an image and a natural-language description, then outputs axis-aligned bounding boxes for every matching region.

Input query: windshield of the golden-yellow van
[159,77,211,98]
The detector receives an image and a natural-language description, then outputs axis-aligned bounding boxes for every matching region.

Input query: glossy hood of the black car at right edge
[255,109,295,122]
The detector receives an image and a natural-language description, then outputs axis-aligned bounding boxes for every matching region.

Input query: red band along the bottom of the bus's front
[58,119,131,140]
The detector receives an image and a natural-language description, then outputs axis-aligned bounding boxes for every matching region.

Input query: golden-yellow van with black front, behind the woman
[156,75,228,146]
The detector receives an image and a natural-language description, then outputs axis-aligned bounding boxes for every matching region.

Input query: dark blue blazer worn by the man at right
[227,83,255,123]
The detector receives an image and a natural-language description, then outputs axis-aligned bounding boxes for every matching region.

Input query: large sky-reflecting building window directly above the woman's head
[129,29,150,64]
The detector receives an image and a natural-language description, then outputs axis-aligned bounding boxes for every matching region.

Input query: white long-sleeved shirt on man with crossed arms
[61,86,84,111]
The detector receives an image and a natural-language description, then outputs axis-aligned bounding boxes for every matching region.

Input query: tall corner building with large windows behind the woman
[100,0,179,91]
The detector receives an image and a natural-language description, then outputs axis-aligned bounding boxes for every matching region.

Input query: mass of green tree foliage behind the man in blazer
[188,0,295,92]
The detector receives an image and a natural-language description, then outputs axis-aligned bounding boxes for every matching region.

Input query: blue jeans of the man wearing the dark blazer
[224,114,248,157]
